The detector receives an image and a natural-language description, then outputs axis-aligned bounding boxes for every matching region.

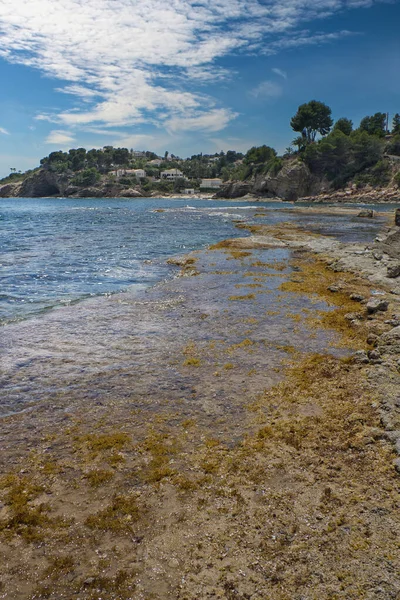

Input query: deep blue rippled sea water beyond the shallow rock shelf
[0,198,388,323]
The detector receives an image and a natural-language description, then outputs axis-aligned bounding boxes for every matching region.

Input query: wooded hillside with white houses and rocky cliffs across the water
[0,105,400,201]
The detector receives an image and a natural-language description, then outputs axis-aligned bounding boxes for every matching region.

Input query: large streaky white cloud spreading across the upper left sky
[0,0,380,137]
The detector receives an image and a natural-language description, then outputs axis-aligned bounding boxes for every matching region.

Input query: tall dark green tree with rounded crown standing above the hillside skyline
[290,100,333,144]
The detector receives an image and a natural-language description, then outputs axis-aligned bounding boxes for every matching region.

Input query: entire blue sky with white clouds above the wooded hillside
[0,0,400,176]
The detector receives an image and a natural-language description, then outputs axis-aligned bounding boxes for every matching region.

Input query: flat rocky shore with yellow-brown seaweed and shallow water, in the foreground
[1,209,400,600]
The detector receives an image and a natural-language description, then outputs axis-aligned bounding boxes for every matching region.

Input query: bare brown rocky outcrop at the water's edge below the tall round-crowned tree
[252,160,327,200]
